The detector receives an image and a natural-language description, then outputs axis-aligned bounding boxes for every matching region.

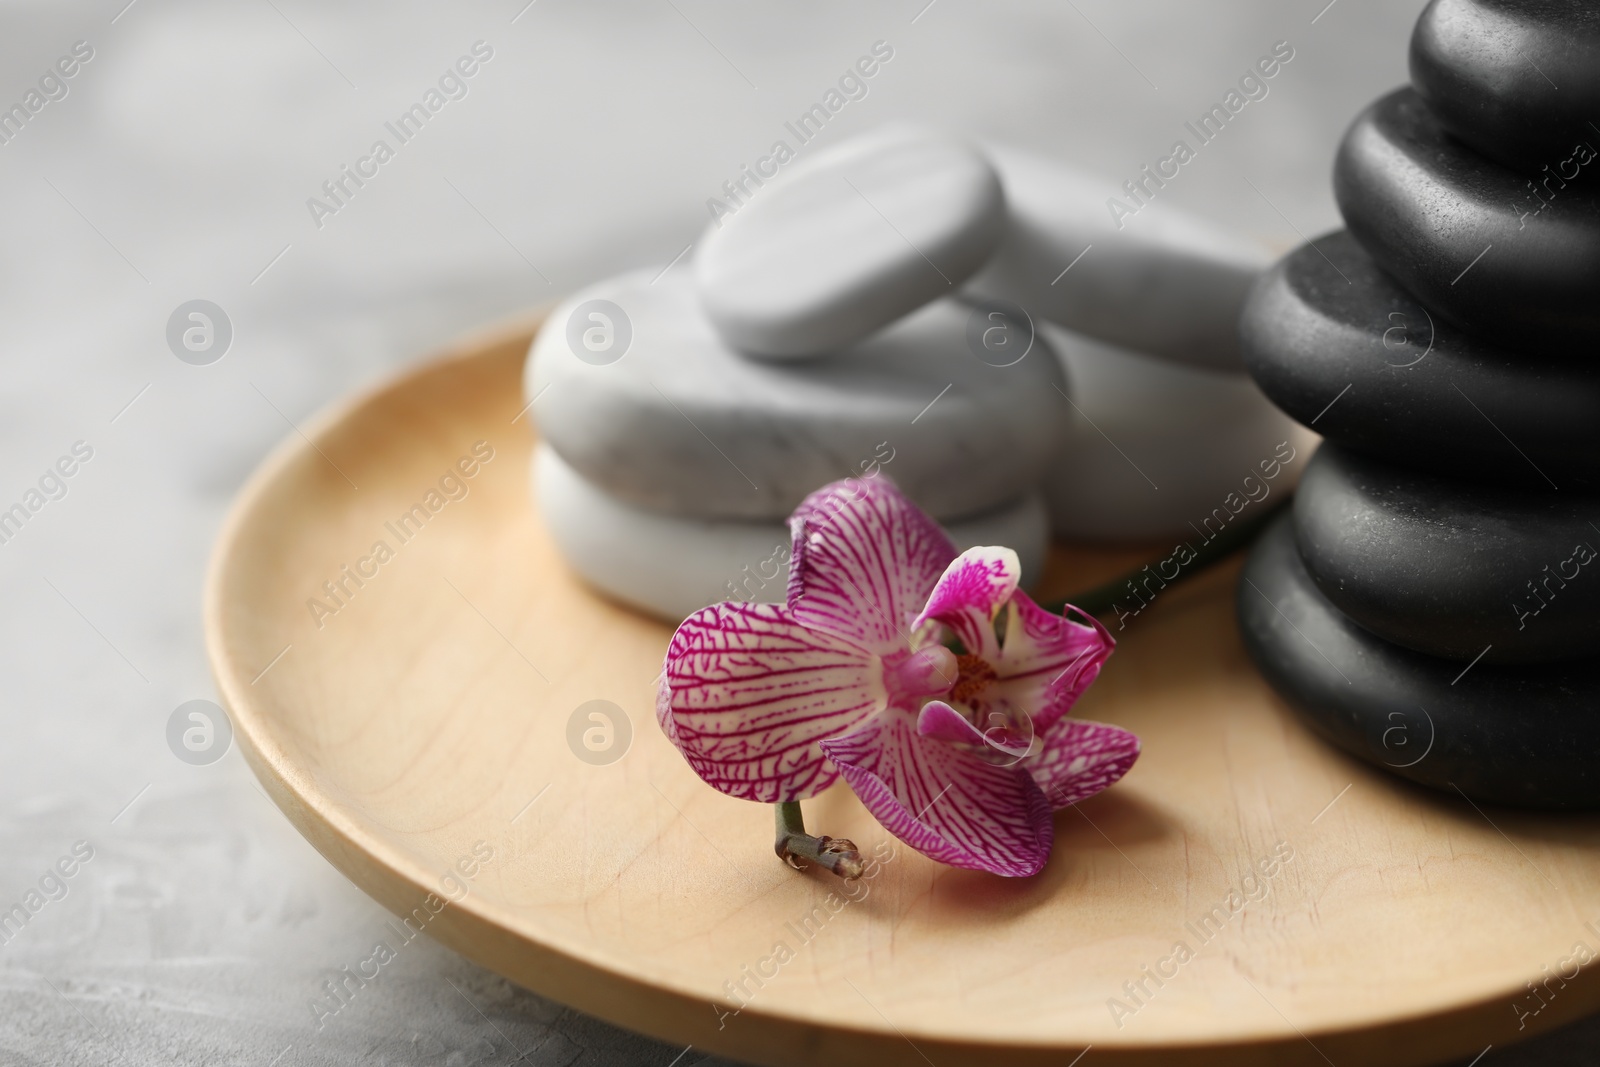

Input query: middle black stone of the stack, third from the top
[1240,232,1600,491]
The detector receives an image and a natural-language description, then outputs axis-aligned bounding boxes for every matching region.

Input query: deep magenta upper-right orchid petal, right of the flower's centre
[971,592,1117,734]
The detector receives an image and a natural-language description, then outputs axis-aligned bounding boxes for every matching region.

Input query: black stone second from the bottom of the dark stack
[1294,445,1600,664]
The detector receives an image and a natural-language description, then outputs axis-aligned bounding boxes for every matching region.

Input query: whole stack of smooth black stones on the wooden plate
[1238,0,1600,808]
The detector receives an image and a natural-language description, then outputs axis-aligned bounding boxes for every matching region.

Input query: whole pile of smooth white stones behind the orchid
[525,126,1296,621]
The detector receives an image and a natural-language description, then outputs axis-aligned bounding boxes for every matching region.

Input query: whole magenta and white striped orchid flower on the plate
[656,478,1139,878]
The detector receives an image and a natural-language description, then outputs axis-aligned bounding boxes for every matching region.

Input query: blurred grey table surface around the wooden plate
[0,0,1600,1067]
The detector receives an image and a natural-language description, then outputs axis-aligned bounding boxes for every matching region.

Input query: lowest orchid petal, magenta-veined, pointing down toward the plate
[822,704,1054,878]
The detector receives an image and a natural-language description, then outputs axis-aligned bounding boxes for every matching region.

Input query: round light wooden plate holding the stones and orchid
[206,313,1600,1067]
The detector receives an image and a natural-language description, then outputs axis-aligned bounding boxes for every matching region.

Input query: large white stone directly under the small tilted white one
[525,270,1069,520]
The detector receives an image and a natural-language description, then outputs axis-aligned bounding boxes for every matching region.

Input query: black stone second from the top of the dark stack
[1333,88,1600,350]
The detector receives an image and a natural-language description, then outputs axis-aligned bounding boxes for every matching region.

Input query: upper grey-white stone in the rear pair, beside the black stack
[966,147,1272,371]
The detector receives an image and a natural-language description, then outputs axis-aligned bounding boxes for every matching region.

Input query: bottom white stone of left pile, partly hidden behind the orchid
[531,443,1050,624]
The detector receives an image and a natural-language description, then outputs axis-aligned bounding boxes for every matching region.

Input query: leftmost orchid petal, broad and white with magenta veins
[662,603,885,803]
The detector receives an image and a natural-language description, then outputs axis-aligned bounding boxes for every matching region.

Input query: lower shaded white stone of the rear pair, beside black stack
[1042,326,1320,544]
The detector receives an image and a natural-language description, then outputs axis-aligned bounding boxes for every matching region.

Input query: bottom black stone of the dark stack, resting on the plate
[1238,517,1600,808]
